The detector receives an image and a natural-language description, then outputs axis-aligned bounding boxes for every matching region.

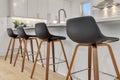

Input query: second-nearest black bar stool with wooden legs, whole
[31,23,69,80]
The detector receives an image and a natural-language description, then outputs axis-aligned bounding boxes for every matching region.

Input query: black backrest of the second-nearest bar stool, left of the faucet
[35,23,51,39]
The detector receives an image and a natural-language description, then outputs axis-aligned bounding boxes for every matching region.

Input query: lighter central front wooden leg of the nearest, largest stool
[92,45,99,80]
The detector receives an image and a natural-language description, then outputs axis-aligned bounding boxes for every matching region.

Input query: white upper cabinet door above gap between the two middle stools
[28,0,39,18]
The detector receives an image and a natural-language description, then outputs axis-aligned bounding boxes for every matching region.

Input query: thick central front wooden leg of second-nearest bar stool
[45,42,50,80]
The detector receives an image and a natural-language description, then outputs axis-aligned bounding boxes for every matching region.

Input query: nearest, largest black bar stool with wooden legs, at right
[66,16,120,80]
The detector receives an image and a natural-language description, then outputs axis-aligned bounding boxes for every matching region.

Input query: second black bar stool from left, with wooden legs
[14,27,42,72]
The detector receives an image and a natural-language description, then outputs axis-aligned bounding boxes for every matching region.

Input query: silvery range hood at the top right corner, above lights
[93,0,120,9]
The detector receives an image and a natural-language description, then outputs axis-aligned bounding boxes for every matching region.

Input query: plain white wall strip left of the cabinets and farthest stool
[0,0,9,55]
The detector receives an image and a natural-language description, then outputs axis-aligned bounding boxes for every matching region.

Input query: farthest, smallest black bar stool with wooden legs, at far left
[4,28,22,64]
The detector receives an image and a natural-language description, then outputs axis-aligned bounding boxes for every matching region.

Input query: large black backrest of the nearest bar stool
[66,16,104,43]
